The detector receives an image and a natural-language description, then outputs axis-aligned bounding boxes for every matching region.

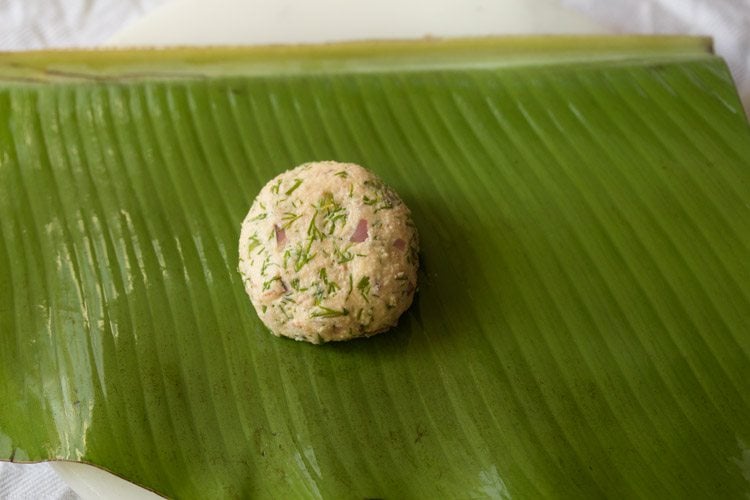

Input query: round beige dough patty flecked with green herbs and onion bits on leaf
[239,161,419,344]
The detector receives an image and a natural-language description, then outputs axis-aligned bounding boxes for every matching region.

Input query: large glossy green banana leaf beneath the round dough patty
[0,37,750,498]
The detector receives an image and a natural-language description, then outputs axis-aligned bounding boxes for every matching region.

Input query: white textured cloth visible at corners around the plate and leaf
[0,0,750,500]
